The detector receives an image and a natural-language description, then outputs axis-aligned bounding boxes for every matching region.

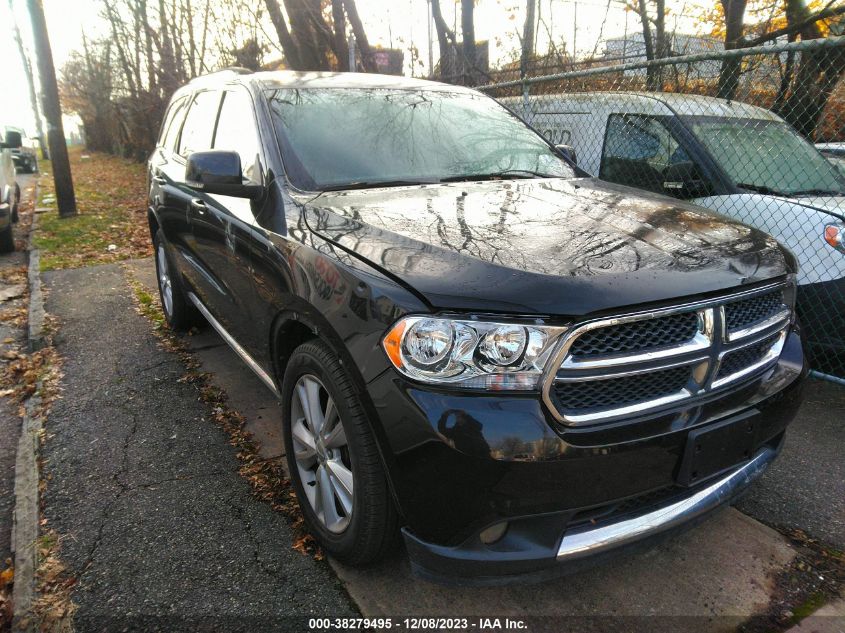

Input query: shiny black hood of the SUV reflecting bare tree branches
[305,179,794,316]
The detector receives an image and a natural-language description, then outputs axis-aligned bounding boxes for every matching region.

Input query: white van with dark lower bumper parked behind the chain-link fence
[502,92,845,372]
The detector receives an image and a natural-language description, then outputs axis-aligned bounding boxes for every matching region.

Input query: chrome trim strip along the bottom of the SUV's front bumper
[557,448,777,561]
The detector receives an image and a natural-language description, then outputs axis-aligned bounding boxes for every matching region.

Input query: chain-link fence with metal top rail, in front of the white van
[468,37,845,384]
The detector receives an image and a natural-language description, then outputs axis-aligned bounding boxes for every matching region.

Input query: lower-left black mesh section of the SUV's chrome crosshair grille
[555,366,691,413]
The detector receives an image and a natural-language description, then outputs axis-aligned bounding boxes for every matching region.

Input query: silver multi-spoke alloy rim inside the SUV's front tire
[290,374,354,534]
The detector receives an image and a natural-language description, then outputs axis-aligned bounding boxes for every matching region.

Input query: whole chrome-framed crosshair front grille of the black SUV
[543,284,789,425]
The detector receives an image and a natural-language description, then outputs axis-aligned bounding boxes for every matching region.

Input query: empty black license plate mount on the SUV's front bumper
[676,411,758,486]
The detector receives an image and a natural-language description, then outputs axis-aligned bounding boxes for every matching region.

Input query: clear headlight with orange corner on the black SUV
[382,316,566,390]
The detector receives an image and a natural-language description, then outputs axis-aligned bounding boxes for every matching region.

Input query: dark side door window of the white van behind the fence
[599,114,689,193]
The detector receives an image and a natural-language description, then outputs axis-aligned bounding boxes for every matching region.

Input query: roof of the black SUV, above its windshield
[184,69,477,93]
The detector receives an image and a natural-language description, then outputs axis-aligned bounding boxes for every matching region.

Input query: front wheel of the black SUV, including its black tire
[282,340,398,566]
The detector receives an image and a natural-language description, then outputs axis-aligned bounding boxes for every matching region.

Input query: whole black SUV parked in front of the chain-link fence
[149,70,806,583]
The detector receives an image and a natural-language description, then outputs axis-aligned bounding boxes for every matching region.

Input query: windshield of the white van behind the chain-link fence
[685,117,845,196]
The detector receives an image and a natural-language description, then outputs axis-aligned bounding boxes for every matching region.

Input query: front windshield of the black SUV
[267,88,575,190]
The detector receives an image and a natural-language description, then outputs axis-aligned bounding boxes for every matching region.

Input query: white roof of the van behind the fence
[516,92,780,121]
